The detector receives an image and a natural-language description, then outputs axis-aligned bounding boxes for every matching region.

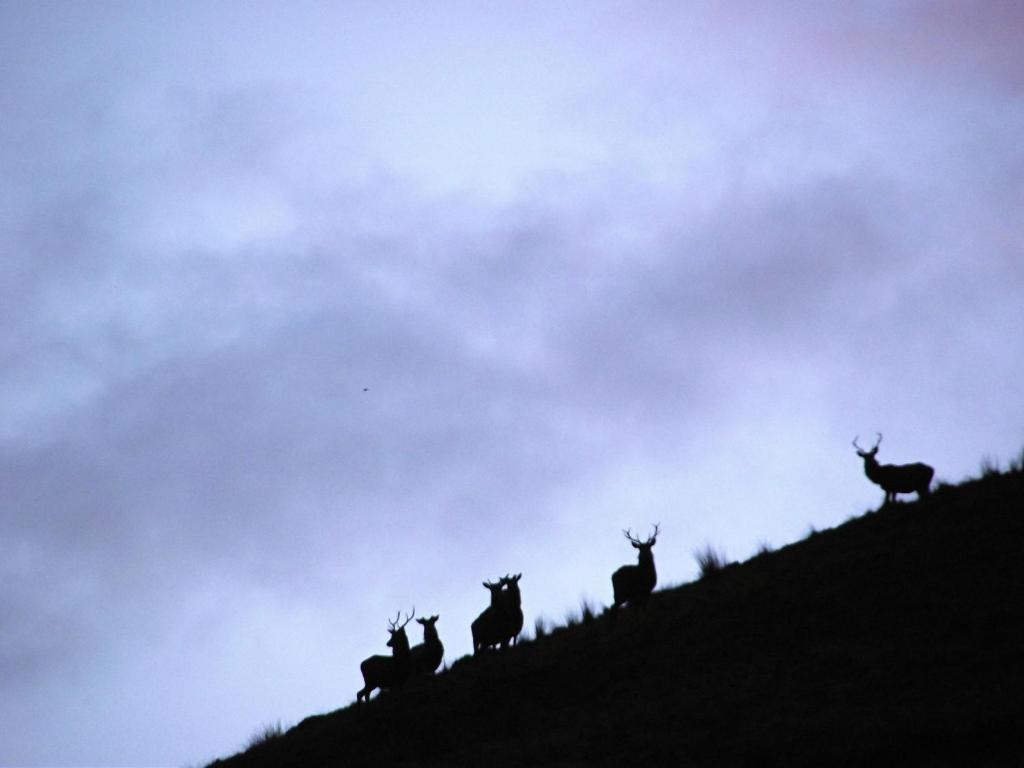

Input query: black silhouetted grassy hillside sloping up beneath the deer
[214,471,1024,768]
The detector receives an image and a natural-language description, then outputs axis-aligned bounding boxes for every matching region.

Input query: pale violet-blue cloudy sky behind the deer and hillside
[0,0,1024,766]
